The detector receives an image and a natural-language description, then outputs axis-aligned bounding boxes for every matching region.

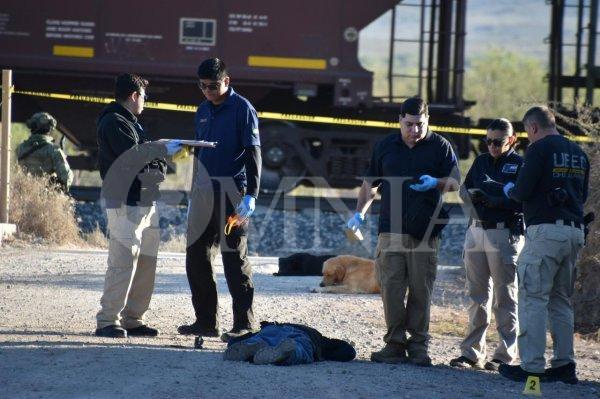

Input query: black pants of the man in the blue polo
[185,188,254,329]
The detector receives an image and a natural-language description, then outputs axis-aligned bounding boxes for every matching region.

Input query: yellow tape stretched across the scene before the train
[13,90,594,142]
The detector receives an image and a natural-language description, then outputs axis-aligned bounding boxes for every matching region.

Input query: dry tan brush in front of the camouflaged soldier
[9,166,83,245]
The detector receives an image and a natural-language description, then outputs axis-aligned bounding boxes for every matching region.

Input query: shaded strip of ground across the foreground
[0,341,600,398]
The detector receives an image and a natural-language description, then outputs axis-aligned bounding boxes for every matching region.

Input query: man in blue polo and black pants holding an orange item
[178,58,261,341]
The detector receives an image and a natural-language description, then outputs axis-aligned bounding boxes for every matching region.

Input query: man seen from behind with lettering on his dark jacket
[499,106,590,384]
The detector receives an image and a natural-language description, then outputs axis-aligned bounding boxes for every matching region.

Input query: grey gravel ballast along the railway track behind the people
[76,202,466,265]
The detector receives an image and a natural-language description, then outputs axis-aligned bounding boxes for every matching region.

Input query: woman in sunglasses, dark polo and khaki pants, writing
[450,119,523,370]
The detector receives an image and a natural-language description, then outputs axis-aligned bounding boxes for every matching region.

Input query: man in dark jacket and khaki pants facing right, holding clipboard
[96,74,181,338]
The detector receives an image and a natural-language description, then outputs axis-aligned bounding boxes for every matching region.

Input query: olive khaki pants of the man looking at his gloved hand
[375,233,438,356]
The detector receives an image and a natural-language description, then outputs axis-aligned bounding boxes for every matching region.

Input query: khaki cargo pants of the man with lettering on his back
[517,221,584,373]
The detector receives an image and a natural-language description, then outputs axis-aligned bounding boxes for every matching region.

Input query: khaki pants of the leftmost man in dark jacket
[96,206,160,328]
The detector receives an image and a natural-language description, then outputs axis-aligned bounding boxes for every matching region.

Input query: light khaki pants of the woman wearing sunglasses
[460,226,523,363]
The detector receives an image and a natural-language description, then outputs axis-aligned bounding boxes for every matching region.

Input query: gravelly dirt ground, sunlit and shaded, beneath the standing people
[0,246,600,399]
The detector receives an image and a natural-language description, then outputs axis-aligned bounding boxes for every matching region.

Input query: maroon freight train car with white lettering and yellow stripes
[0,0,469,194]
